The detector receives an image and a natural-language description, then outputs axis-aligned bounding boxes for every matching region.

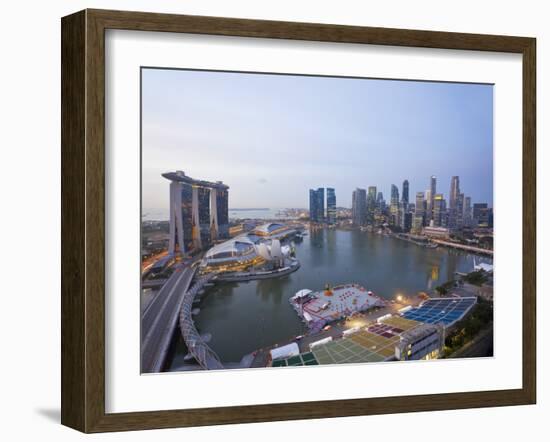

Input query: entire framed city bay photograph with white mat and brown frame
[61,10,536,432]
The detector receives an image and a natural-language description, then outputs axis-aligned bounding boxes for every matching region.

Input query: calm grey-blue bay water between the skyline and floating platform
[170,229,487,362]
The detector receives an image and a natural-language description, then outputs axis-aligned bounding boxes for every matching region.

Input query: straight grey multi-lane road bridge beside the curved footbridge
[141,267,195,373]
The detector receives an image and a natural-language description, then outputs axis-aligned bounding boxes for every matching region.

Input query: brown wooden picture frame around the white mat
[61,10,536,432]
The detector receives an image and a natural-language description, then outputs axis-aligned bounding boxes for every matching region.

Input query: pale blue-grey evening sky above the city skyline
[142,68,493,209]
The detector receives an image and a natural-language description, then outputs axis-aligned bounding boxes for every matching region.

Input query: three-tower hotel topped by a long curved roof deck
[162,170,233,254]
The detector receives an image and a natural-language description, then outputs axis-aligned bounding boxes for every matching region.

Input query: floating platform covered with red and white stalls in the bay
[289,284,387,330]
